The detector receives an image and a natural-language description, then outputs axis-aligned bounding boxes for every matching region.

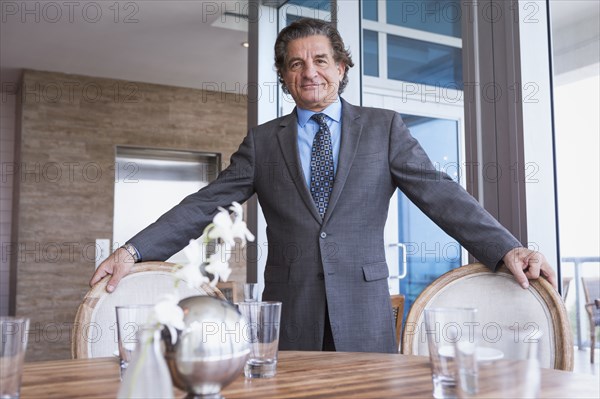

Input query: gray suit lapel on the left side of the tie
[277,109,324,223]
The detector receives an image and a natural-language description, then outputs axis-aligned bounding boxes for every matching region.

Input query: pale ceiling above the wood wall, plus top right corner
[0,0,600,92]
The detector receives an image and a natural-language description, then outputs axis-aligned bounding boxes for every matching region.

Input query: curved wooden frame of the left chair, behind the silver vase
[71,262,226,359]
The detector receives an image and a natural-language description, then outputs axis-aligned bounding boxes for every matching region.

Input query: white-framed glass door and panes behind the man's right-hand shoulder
[362,0,467,318]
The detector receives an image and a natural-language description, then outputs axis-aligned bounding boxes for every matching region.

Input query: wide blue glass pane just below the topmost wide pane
[387,35,463,90]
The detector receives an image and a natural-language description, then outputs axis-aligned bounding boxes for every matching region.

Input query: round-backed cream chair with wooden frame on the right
[402,263,573,371]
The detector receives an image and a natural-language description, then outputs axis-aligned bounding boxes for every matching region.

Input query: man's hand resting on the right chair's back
[502,247,558,290]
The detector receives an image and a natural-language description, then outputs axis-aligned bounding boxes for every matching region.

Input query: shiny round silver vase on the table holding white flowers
[163,296,250,399]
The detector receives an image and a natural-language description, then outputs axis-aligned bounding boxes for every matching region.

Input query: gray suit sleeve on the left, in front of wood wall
[128,130,255,261]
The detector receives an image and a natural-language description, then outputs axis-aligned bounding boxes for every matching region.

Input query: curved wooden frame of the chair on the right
[402,263,574,371]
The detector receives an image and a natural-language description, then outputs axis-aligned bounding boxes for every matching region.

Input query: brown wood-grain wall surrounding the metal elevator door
[11,70,247,360]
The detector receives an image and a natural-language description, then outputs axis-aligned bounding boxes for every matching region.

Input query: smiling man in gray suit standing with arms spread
[90,19,556,353]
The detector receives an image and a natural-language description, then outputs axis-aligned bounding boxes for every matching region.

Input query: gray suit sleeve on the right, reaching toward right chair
[389,114,522,269]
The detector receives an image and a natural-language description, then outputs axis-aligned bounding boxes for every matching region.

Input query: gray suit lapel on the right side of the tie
[324,99,362,223]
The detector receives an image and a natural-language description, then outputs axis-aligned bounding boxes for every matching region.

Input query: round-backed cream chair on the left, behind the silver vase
[71,262,225,359]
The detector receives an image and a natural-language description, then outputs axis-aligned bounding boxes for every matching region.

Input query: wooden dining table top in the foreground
[21,351,600,399]
